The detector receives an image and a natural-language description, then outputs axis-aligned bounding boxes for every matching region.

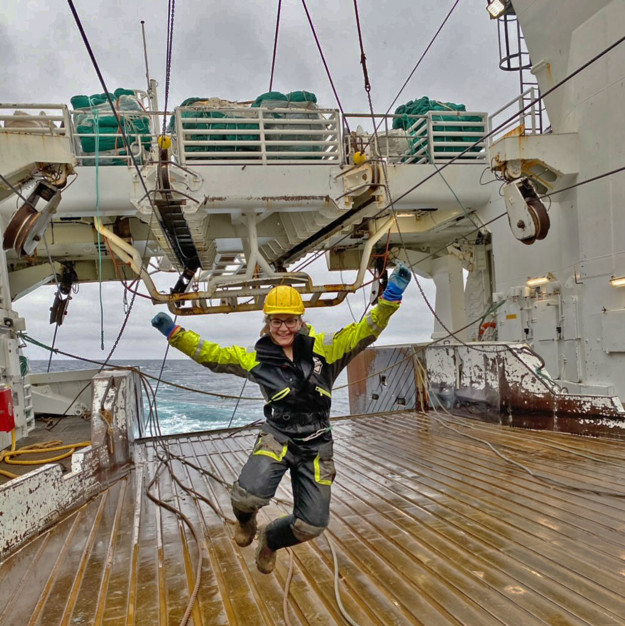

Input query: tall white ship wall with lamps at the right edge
[476,0,625,398]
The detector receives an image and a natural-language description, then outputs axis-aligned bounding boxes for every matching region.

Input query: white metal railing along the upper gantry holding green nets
[0,103,489,167]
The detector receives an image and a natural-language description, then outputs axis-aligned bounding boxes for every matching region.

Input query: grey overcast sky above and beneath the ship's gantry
[0,0,518,360]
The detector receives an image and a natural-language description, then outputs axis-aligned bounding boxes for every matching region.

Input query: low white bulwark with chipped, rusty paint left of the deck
[0,371,142,559]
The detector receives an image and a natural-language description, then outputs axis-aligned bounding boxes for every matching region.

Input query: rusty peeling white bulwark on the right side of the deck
[348,342,625,435]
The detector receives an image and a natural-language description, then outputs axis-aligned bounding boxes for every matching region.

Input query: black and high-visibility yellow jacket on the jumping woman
[169,299,399,437]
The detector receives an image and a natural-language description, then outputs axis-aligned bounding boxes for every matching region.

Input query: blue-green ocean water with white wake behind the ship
[29,359,349,434]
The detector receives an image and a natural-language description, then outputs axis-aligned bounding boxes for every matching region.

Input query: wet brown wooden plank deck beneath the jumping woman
[0,412,625,626]
